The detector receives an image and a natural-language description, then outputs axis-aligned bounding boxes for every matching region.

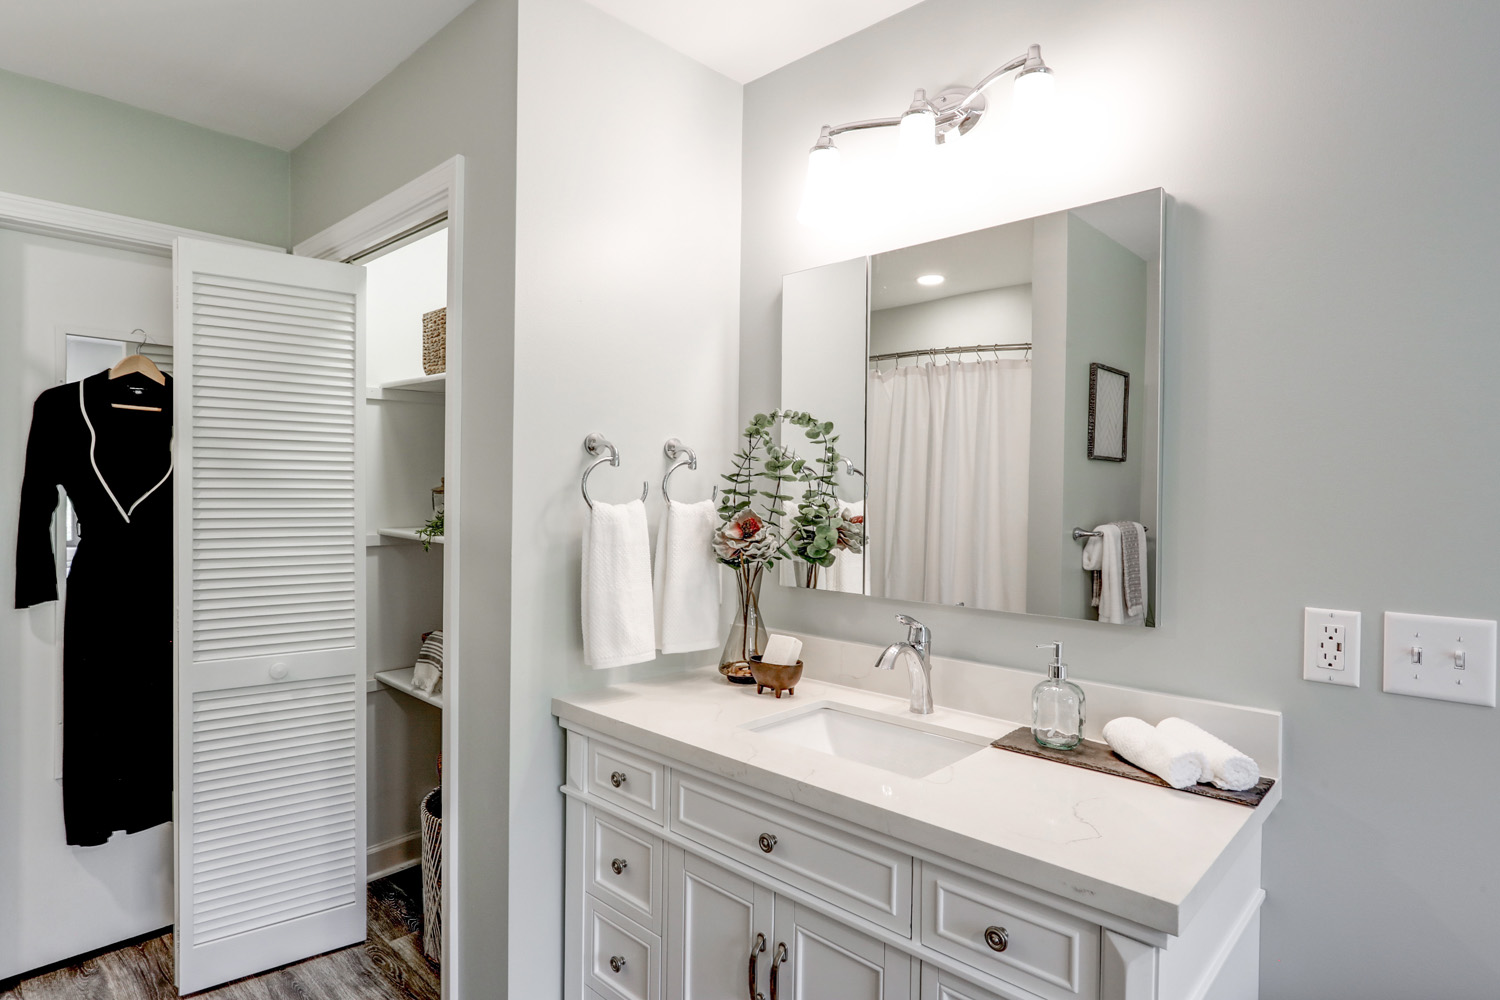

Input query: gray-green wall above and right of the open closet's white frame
[291,0,518,997]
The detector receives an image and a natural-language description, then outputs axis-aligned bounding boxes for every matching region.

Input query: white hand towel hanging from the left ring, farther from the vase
[582,501,656,670]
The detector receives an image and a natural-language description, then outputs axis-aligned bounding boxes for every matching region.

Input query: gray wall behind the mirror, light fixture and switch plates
[740,0,1500,1000]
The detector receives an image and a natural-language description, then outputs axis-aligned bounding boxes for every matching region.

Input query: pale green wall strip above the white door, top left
[0,70,290,246]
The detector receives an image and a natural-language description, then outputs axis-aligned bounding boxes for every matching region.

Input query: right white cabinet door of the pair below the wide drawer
[767,897,912,1000]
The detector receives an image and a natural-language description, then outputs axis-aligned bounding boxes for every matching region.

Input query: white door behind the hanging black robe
[0,229,173,981]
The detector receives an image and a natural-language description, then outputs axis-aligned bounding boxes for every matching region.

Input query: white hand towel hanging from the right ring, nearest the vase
[656,501,723,652]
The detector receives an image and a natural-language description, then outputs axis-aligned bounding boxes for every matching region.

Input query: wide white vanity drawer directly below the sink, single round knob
[671,772,912,936]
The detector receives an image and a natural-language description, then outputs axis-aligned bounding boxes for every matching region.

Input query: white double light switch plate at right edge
[1383,612,1496,708]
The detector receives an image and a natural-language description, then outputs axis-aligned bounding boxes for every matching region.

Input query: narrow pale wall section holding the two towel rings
[516,0,744,999]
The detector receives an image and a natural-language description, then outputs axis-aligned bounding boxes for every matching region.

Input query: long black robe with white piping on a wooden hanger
[15,372,173,847]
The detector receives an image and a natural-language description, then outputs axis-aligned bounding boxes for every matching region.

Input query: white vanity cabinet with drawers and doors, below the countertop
[563,721,1260,1000]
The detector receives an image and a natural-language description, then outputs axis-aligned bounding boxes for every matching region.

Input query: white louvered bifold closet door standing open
[174,240,366,993]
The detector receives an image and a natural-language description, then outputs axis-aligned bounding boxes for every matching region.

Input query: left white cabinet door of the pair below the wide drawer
[675,847,773,1000]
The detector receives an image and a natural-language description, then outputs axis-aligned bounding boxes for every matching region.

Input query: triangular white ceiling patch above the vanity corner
[588,0,920,84]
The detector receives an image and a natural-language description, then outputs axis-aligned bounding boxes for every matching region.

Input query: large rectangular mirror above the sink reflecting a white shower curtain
[780,189,1166,625]
